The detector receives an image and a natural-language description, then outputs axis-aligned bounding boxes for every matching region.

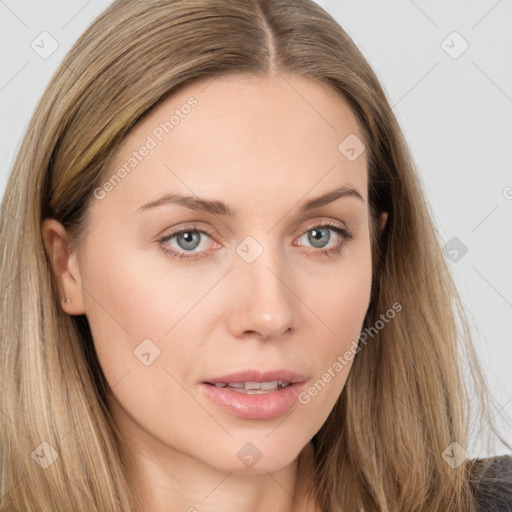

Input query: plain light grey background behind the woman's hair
[0,0,512,456]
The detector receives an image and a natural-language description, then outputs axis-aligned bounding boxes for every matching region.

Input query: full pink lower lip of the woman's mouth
[200,382,304,420]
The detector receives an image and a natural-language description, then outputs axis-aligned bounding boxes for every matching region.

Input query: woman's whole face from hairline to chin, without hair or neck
[54,75,371,473]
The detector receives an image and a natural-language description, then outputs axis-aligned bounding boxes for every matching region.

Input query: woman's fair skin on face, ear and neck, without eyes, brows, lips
[43,75,386,512]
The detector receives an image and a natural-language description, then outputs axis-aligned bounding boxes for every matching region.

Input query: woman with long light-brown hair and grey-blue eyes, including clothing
[0,0,512,512]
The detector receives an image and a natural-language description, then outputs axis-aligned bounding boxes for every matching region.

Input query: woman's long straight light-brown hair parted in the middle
[0,0,512,512]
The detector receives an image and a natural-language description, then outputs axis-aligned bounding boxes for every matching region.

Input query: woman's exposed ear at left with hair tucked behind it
[42,219,85,315]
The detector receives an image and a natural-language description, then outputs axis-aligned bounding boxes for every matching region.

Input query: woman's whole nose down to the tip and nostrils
[227,245,297,340]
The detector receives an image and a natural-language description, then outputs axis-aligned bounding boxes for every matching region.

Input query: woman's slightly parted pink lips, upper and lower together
[200,370,306,420]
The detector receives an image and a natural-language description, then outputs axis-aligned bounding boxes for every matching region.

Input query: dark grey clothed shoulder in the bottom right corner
[468,454,512,512]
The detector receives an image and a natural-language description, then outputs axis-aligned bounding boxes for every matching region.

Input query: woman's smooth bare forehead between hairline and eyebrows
[95,75,367,220]
